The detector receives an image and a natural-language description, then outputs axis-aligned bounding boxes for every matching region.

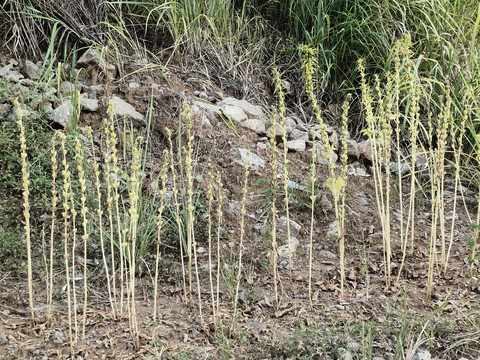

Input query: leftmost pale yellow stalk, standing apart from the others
[13,98,35,325]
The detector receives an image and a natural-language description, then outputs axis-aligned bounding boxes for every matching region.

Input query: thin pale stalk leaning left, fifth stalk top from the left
[87,127,116,318]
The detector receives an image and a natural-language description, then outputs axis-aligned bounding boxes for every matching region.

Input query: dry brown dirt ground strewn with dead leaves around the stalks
[0,54,480,359]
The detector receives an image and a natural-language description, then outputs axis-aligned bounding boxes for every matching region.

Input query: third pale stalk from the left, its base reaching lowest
[59,133,73,354]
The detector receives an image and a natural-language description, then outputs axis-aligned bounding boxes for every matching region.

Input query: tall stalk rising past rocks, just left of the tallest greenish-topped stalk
[272,68,292,272]
